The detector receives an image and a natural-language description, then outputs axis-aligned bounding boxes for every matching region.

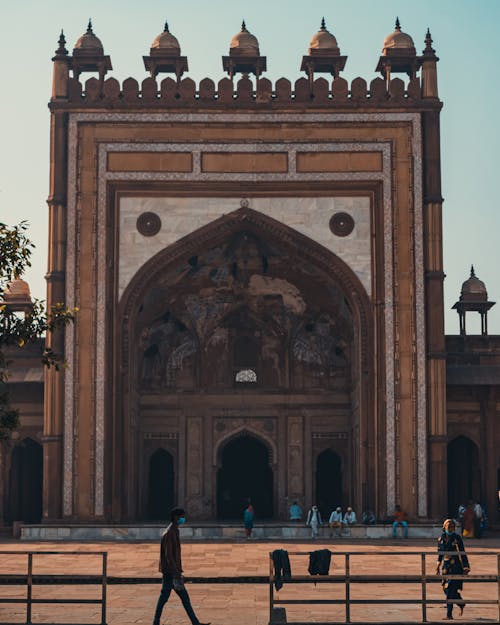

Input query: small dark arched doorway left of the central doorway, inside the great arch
[147,449,174,521]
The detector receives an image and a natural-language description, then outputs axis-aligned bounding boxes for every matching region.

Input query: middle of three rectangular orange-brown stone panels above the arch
[201,152,288,173]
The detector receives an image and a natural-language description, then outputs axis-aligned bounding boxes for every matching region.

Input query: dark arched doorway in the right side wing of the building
[448,436,481,517]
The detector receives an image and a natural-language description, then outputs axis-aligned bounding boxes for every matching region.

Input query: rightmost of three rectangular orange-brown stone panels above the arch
[297,152,382,173]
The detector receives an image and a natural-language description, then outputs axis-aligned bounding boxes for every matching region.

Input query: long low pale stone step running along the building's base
[20,523,442,541]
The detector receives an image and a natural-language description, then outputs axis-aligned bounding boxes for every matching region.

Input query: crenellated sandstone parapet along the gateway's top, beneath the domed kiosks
[57,76,436,108]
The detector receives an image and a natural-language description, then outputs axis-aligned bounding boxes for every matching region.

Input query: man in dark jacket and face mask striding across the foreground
[153,508,210,625]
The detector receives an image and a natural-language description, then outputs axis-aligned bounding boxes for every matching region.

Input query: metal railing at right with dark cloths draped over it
[269,551,500,625]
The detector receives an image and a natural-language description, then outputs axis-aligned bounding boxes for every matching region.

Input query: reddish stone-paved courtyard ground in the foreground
[0,538,500,625]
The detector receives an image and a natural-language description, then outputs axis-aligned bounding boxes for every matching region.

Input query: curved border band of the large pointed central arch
[108,207,377,518]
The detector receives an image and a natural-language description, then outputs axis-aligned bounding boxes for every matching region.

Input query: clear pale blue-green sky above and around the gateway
[0,0,500,334]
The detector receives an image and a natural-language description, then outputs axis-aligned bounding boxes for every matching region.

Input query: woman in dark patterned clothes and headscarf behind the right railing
[436,519,470,620]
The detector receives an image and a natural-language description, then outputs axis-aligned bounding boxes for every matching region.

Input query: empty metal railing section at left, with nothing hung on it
[0,551,108,625]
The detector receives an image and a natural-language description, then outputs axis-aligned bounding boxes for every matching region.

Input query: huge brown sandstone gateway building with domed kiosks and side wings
[0,22,500,523]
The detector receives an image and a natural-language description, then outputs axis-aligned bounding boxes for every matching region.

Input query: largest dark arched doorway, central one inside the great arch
[217,435,273,520]
